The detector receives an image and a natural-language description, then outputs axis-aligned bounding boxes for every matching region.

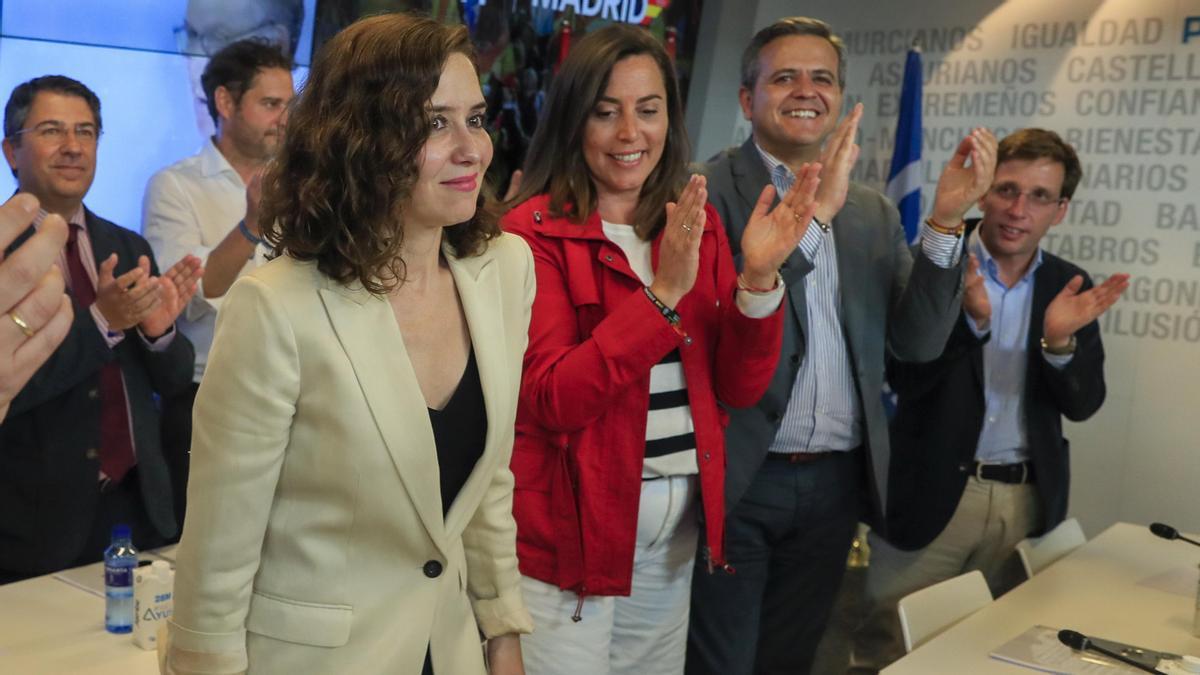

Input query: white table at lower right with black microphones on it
[883,522,1200,675]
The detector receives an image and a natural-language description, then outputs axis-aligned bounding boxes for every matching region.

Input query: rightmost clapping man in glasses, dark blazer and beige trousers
[854,129,1129,670]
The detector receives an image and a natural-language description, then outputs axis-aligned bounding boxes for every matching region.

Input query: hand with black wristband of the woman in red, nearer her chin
[650,175,708,309]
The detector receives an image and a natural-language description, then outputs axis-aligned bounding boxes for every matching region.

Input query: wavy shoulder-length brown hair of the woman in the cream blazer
[258,13,499,295]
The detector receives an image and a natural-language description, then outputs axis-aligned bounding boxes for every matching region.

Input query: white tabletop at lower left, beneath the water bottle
[0,554,174,675]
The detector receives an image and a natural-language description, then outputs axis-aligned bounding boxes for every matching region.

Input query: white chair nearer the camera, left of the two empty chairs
[896,569,991,653]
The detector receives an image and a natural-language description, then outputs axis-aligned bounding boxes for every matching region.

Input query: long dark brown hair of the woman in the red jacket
[510,24,691,239]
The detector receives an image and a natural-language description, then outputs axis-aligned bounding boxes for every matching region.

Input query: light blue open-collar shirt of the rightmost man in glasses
[967,229,1072,464]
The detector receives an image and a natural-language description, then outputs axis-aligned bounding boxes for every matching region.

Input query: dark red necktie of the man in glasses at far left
[67,223,133,483]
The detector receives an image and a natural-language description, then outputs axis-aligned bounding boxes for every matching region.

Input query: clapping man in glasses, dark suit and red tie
[0,76,202,583]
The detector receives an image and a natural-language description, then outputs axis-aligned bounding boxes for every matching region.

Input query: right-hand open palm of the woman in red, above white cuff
[742,165,825,288]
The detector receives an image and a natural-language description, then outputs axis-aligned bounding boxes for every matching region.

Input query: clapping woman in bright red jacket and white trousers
[503,25,818,675]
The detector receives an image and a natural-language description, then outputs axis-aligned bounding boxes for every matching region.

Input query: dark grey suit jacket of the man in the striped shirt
[704,138,962,526]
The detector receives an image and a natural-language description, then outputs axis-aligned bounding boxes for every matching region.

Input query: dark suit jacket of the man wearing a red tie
[0,211,194,574]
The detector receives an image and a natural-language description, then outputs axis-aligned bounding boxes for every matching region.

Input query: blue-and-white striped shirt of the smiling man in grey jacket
[755,144,961,453]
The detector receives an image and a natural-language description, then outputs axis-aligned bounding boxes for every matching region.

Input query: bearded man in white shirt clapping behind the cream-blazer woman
[142,38,295,519]
